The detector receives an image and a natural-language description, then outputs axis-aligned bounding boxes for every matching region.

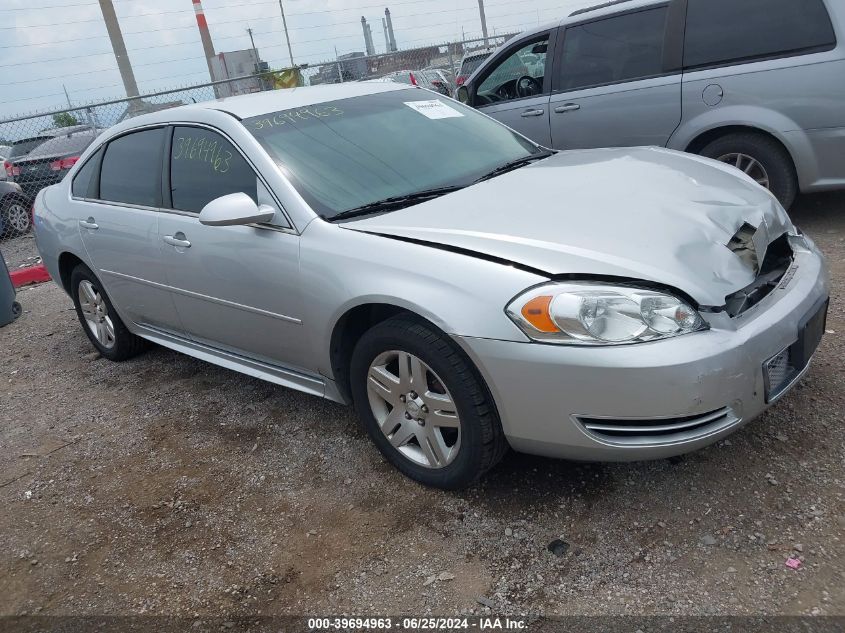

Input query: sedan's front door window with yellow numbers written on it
[170,127,258,213]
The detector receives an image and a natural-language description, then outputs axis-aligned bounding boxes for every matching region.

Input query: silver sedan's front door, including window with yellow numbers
[158,127,305,367]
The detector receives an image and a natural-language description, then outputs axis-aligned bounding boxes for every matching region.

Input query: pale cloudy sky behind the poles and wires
[0,0,595,119]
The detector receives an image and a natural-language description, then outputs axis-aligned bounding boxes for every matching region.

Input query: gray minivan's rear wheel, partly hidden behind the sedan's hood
[701,132,798,209]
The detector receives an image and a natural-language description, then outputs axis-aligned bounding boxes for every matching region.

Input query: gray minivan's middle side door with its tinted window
[549,2,683,149]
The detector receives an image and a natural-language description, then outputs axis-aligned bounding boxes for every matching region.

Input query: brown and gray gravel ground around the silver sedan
[0,194,845,616]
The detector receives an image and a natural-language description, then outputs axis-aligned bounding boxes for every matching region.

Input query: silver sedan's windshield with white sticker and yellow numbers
[243,88,540,219]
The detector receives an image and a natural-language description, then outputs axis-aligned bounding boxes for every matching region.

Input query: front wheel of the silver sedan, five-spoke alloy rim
[350,315,507,489]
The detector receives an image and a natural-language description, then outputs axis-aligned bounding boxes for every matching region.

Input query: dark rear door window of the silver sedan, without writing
[100,128,164,207]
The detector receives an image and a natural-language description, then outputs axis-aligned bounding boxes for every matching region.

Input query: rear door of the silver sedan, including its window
[72,127,181,333]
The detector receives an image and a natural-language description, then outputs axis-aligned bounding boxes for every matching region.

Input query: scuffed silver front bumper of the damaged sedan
[456,237,828,461]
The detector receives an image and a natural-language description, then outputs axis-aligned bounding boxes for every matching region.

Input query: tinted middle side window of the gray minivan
[557,7,668,90]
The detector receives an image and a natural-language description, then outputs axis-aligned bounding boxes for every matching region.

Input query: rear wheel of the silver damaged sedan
[70,264,146,361]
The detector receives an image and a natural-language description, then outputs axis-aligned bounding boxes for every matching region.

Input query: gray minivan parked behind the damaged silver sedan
[457,0,845,207]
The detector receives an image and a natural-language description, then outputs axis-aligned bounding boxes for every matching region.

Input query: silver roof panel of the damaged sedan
[121,81,411,127]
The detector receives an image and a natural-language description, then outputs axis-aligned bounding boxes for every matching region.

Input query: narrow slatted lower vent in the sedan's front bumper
[577,407,739,446]
